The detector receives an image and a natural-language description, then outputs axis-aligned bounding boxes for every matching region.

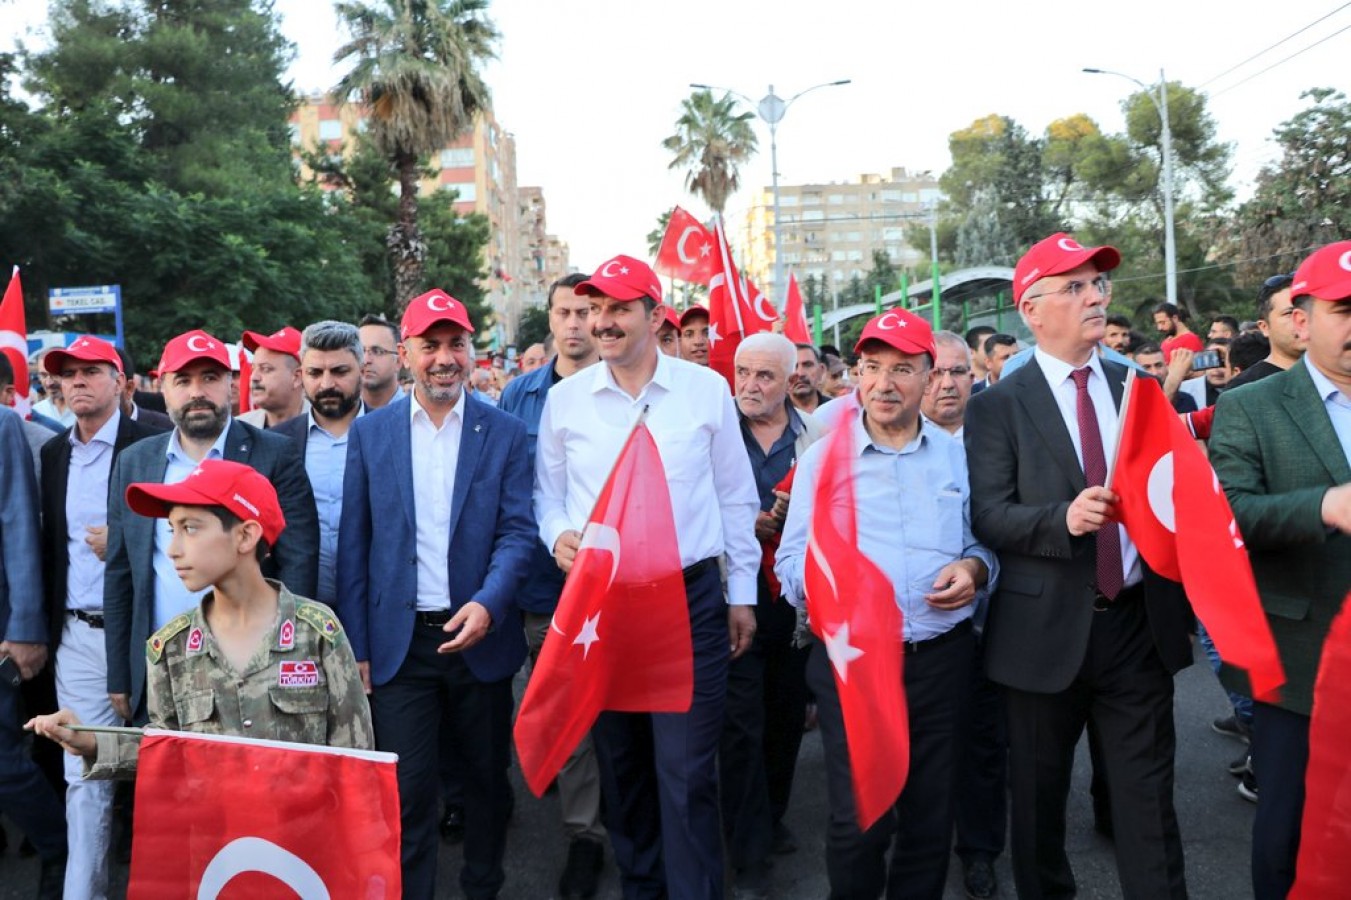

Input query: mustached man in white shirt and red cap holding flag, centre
[535,255,761,897]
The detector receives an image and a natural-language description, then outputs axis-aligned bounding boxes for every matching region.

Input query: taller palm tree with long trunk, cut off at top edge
[334,0,500,309]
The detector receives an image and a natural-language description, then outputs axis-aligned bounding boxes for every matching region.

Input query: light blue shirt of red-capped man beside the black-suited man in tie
[774,412,998,641]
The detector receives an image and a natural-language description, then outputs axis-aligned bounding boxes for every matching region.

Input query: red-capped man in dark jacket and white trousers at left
[41,336,159,897]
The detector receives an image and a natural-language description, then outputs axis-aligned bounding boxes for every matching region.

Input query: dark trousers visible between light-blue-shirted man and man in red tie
[957,637,1009,862]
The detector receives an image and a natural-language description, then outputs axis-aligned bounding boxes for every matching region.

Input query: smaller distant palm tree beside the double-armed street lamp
[662,89,755,215]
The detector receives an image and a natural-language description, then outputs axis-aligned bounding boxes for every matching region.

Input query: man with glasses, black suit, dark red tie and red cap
[966,234,1192,900]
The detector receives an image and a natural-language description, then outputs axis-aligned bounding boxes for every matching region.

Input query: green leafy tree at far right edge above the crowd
[1227,88,1351,285]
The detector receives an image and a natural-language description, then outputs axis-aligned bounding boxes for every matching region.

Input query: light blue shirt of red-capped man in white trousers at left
[66,409,122,612]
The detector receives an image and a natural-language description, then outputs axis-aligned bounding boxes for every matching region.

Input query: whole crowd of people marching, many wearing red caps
[0,234,1351,900]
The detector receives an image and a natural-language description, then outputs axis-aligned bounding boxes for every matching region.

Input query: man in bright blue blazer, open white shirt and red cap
[336,291,536,899]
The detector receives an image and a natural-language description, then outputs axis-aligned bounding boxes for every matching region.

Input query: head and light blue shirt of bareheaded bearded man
[274,320,366,605]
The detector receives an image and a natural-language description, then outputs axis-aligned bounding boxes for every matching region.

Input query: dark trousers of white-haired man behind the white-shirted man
[717,597,808,876]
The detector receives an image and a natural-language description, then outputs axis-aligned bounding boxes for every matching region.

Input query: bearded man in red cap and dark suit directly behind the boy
[103,331,319,722]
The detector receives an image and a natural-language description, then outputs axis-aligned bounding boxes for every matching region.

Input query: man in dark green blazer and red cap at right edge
[1210,241,1351,900]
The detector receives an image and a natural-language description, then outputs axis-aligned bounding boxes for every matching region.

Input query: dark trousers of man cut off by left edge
[0,681,66,859]
